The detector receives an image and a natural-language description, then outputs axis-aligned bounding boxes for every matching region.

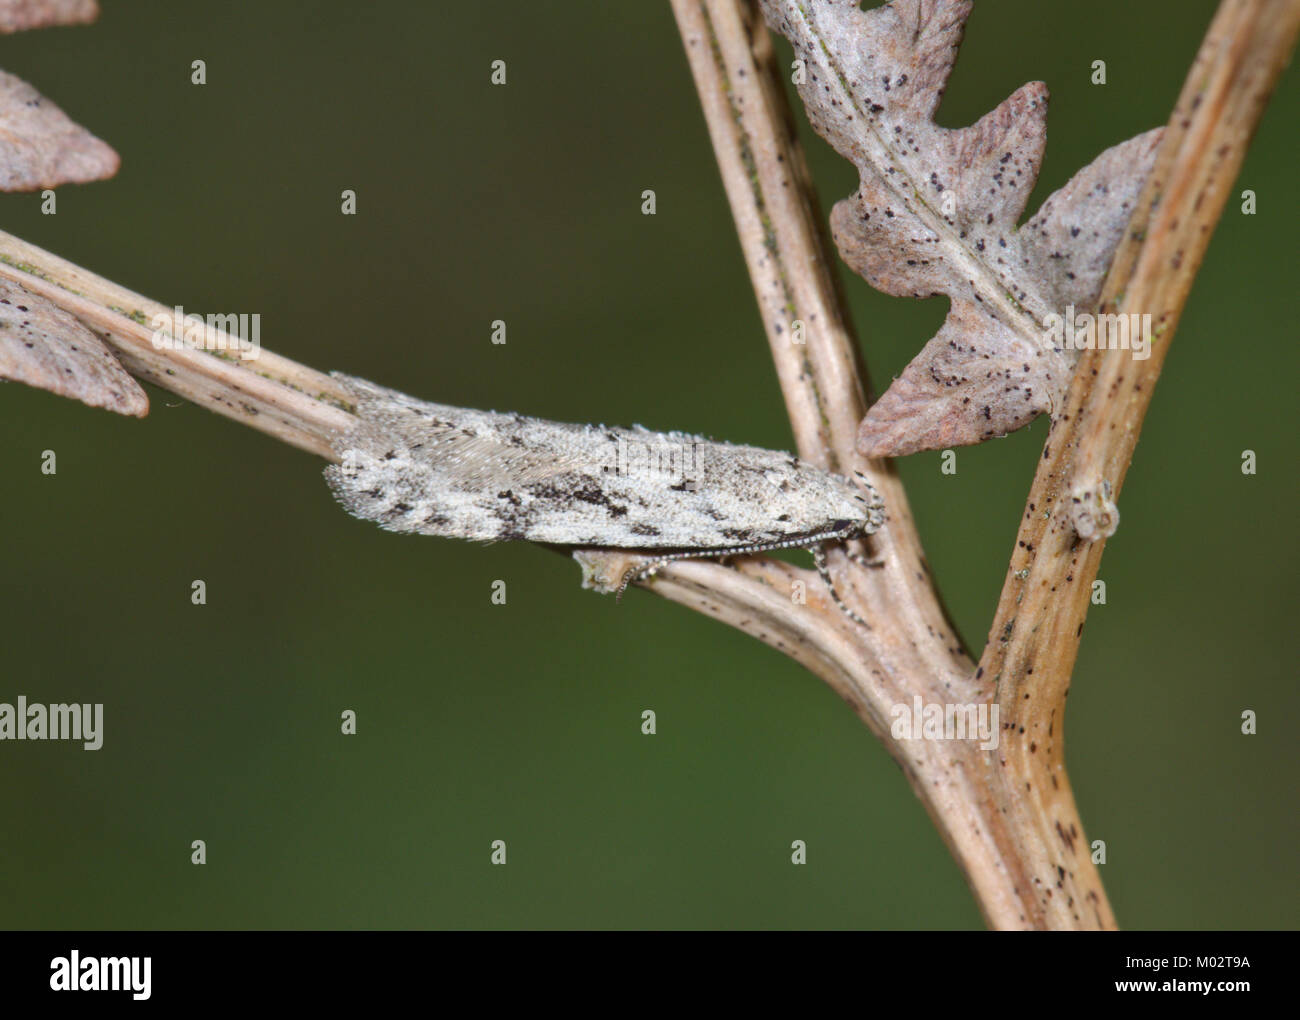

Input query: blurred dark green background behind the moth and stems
[0,0,1300,928]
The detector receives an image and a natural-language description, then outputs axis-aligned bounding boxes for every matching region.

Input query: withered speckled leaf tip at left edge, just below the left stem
[0,278,150,418]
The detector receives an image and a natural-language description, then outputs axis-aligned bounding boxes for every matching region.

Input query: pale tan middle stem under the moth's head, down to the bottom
[651,0,1112,928]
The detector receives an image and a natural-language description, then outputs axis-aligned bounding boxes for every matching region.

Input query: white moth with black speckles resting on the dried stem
[325,372,884,618]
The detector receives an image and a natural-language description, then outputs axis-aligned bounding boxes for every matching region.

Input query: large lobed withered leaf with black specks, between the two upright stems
[762,0,1161,456]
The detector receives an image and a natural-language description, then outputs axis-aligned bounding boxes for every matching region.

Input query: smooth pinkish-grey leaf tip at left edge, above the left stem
[0,71,121,191]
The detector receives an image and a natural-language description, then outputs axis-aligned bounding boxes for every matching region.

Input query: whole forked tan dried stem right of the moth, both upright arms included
[653,0,1296,929]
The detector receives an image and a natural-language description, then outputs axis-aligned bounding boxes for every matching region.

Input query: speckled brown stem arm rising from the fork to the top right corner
[980,0,1300,919]
